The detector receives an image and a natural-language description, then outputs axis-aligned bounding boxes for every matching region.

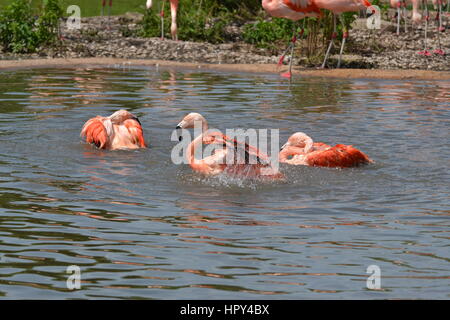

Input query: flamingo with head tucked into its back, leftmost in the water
[80,109,146,150]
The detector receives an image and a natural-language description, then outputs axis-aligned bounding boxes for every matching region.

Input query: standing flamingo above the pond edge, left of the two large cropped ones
[262,0,321,78]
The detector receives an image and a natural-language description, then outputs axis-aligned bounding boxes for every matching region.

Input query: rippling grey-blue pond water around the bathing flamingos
[0,68,450,299]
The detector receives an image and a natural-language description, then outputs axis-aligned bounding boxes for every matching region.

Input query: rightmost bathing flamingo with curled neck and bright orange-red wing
[279,132,373,168]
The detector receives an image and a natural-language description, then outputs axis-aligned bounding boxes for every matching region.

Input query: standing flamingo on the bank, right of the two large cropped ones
[311,0,372,68]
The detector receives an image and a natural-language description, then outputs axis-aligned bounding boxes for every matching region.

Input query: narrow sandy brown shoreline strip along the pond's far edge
[0,57,450,80]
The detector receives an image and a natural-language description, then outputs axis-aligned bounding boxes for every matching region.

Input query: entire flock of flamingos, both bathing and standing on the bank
[81,0,449,179]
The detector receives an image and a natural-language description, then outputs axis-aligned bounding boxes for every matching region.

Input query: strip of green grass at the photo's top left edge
[0,0,146,17]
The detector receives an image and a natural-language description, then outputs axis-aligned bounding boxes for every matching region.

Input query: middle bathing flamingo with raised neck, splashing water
[176,112,282,179]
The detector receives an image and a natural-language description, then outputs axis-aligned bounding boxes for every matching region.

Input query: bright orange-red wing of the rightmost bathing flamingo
[306,144,372,168]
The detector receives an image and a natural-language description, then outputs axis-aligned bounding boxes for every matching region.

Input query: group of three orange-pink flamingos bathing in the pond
[80,109,372,179]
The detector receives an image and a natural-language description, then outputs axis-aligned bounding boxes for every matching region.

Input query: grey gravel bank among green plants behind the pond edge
[0,14,450,71]
